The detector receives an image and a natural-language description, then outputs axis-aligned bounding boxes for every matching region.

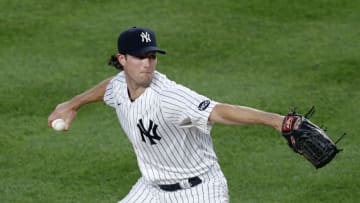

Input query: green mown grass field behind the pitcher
[0,0,360,203]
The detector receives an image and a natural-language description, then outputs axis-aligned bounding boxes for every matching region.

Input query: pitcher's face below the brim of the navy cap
[122,52,157,87]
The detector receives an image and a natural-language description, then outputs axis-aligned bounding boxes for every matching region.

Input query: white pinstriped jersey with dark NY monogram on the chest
[104,71,217,184]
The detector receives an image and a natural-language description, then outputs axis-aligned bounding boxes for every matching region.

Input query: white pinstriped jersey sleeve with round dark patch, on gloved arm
[160,84,217,133]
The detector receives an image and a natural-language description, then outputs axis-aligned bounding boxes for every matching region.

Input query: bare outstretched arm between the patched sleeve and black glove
[209,104,284,131]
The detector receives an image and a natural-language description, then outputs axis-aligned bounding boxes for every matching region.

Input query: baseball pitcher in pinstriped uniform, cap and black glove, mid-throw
[48,27,339,203]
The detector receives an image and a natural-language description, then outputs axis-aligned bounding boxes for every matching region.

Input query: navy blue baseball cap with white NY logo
[118,27,166,56]
